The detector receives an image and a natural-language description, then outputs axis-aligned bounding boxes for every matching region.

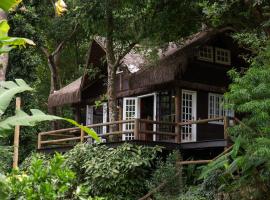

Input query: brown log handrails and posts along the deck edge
[38,117,231,149]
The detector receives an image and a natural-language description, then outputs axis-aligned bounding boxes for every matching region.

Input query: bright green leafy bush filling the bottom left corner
[0,154,75,200]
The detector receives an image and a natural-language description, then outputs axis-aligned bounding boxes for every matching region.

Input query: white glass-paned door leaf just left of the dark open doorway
[122,97,138,140]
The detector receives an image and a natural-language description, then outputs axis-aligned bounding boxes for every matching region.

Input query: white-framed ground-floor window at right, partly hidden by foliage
[208,93,234,124]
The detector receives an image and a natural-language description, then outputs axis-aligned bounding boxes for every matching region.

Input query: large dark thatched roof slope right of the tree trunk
[118,27,233,97]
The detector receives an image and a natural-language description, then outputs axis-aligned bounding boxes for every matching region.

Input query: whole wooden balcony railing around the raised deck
[38,117,232,149]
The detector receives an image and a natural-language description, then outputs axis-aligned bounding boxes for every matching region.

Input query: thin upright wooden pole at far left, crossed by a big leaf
[13,97,21,169]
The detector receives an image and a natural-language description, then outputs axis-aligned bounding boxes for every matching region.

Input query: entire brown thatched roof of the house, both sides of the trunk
[48,27,233,107]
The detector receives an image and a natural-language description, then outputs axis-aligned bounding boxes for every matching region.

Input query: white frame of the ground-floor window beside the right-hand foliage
[208,92,234,125]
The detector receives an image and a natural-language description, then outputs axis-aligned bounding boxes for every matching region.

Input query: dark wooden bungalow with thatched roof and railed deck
[39,28,247,158]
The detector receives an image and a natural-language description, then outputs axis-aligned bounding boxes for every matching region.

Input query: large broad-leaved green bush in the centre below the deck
[66,144,160,200]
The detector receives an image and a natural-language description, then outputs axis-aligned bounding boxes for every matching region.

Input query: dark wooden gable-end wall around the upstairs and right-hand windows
[178,34,247,141]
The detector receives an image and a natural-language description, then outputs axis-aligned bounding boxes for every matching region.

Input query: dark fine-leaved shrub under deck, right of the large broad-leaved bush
[147,151,184,200]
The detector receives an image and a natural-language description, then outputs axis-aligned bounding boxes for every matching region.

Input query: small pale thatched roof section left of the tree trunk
[48,77,82,107]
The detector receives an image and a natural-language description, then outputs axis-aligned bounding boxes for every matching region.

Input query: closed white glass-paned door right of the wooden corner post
[181,90,197,142]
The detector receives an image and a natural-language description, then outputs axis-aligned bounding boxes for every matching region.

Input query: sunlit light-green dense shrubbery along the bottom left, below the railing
[0,154,106,200]
